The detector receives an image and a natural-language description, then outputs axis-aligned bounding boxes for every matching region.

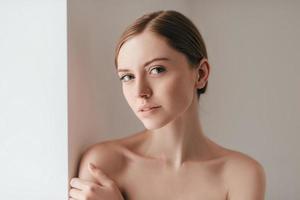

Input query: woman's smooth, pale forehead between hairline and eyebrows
[118,31,183,68]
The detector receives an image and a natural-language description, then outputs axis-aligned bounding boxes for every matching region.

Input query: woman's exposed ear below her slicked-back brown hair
[195,58,210,89]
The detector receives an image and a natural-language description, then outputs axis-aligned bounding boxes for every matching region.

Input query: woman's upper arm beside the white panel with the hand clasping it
[70,144,124,200]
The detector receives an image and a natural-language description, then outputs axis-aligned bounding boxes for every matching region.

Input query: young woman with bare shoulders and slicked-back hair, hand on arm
[70,11,265,200]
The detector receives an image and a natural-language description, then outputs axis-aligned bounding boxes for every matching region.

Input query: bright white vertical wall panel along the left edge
[0,0,68,200]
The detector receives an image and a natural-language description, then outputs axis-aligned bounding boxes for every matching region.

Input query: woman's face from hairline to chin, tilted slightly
[118,31,198,129]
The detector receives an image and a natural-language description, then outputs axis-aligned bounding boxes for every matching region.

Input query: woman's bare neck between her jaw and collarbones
[143,97,207,169]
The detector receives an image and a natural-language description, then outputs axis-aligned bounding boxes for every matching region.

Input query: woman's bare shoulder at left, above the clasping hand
[78,140,126,181]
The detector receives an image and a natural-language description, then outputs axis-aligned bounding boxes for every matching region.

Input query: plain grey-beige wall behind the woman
[68,0,300,200]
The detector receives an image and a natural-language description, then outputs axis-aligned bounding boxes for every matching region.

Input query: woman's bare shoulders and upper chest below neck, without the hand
[74,130,265,200]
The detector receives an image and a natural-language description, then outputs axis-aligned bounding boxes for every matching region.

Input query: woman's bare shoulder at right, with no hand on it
[224,151,266,200]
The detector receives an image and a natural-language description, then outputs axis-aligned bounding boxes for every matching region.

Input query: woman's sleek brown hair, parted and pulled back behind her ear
[114,10,208,99]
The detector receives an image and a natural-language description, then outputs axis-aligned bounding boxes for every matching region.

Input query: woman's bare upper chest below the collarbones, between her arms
[120,162,226,200]
